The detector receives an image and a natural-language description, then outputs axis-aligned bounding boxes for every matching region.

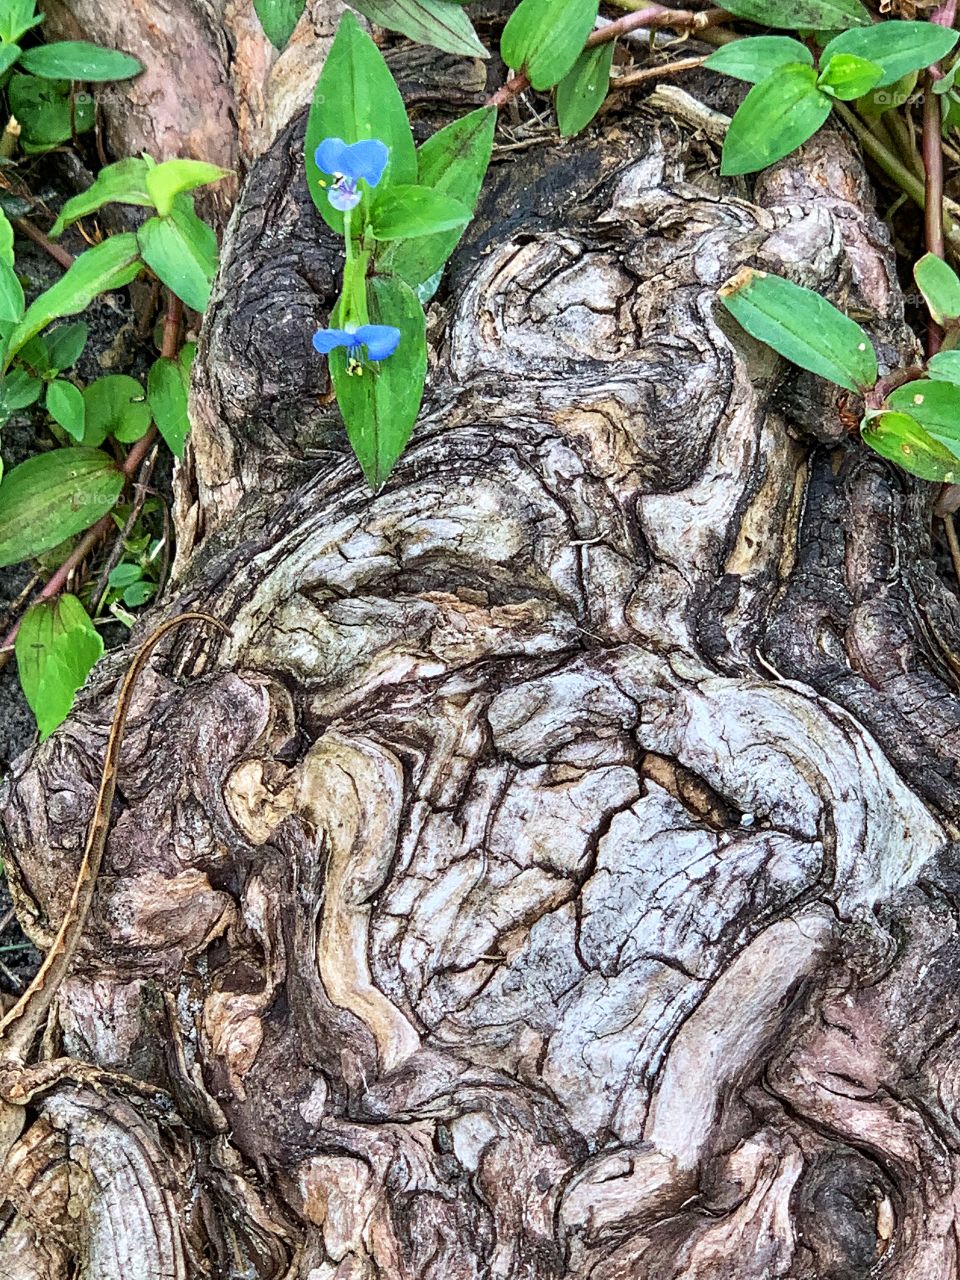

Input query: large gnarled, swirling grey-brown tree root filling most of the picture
[0,17,960,1280]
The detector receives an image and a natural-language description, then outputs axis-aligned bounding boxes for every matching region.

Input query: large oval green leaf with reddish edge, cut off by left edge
[0,448,123,567]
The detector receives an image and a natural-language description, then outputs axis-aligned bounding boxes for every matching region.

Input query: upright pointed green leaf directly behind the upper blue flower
[305,10,417,234]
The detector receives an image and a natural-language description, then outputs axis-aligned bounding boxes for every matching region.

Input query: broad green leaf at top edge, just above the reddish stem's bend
[500,0,599,88]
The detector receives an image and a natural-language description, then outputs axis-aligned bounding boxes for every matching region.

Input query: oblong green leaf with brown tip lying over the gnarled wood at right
[719,266,877,392]
